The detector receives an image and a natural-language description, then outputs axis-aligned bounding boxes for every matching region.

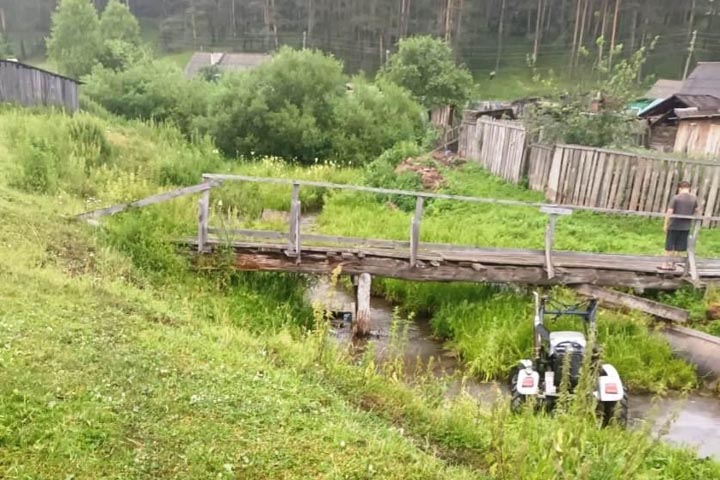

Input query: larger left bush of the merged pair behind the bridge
[209,48,345,164]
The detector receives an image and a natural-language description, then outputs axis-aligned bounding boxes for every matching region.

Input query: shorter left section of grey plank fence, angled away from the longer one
[459,117,526,183]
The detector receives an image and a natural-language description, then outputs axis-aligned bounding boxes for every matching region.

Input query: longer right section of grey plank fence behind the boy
[528,145,720,223]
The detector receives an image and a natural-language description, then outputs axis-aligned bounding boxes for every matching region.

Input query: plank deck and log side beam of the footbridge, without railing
[184,235,720,290]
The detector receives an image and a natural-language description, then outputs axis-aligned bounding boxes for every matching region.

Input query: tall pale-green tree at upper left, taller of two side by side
[47,0,102,78]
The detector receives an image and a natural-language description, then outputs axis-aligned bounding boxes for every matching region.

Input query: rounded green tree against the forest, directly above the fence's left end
[378,36,473,110]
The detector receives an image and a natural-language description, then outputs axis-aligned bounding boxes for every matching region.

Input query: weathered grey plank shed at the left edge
[0,60,81,112]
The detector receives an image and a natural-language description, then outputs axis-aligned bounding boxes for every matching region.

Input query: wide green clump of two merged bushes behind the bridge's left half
[207,48,424,165]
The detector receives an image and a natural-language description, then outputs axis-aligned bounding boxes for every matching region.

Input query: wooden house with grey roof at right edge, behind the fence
[639,62,720,156]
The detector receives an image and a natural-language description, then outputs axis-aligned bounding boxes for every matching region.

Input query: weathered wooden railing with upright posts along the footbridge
[197,174,720,281]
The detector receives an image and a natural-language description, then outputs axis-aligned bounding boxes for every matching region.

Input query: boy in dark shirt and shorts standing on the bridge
[660,181,698,270]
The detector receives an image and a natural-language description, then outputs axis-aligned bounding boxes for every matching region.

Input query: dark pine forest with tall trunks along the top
[0,0,720,77]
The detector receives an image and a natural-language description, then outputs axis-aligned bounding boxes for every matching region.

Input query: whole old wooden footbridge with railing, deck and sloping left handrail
[80,174,720,291]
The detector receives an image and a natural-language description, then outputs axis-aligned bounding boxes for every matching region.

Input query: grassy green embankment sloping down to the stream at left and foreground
[0,107,720,480]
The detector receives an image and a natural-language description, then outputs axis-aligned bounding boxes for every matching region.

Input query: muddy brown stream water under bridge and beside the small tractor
[308,281,720,460]
